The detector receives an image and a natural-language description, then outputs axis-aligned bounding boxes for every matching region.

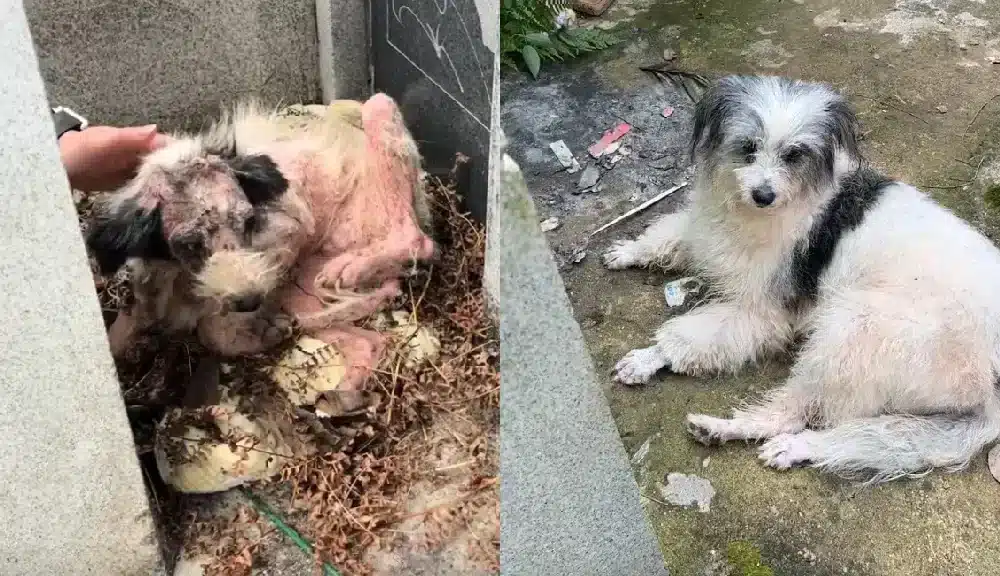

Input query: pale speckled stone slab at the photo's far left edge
[0,2,159,576]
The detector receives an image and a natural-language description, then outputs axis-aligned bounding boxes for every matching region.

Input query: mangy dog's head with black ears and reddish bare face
[87,138,288,311]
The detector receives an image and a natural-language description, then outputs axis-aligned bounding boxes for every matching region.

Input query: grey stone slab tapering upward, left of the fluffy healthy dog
[489,147,667,576]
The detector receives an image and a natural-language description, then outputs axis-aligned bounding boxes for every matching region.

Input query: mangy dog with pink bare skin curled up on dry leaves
[87,94,434,386]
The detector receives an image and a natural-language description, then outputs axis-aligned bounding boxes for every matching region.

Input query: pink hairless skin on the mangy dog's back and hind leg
[268,94,435,390]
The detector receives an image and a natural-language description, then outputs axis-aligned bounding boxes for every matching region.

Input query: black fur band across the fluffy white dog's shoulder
[788,168,893,307]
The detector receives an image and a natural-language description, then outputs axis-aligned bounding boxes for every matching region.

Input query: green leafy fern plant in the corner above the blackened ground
[500,0,621,78]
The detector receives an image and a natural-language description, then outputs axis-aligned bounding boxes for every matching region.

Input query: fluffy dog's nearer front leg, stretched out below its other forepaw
[615,302,793,384]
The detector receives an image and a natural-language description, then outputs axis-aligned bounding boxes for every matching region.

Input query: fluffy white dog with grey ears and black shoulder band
[604,76,1000,482]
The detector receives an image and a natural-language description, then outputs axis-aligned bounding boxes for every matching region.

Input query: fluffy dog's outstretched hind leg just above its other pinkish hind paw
[687,377,815,446]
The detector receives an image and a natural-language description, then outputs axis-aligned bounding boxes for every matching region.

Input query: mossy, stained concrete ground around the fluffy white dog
[501,0,1000,575]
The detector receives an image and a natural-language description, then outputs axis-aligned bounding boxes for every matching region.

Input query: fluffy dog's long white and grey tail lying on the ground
[807,391,1000,484]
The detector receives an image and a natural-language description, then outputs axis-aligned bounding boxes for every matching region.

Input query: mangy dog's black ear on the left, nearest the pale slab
[86,201,172,275]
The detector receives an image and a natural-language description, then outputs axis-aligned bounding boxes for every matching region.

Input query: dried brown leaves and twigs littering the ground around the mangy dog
[81,172,500,576]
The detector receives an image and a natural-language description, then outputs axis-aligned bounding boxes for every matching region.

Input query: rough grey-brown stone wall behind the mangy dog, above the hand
[24,0,320,129]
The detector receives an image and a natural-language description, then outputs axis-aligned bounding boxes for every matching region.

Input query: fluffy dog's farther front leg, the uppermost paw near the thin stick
[604,210,689,270]
